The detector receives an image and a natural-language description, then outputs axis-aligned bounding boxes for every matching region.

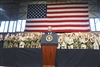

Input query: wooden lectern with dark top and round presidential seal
[41,34,58,67]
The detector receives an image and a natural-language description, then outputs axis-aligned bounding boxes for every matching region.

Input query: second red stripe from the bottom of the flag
[26,24,89,28]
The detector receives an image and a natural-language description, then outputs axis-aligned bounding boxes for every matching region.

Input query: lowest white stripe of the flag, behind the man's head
[25,27,90,30]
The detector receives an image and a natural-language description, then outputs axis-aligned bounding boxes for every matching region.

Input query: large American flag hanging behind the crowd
[25,2,90,32]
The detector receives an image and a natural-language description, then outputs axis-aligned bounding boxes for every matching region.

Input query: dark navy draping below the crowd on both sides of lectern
[0,48,100,67]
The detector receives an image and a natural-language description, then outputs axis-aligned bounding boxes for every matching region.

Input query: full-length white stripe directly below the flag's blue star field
[27,17,89,21]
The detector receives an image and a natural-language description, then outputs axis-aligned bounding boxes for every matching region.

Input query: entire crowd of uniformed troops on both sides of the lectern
[0,32,100,49]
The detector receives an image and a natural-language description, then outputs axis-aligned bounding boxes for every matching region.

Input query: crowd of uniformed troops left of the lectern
[3,33,41,48]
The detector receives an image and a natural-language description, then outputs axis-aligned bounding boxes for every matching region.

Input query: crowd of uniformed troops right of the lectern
[58,32,100,49]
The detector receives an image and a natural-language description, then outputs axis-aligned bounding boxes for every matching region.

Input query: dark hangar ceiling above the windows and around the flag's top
[0,0,100,20]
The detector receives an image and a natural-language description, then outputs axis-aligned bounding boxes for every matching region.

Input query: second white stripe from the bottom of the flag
[26,22,89,26]
